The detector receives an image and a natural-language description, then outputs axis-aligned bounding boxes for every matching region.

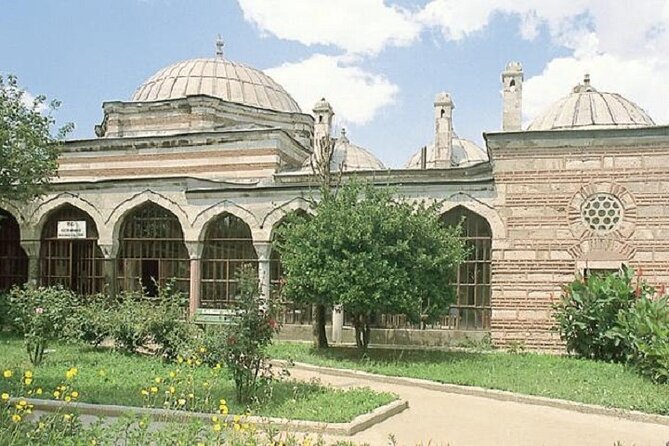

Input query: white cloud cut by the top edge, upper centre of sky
[238,0,420,54]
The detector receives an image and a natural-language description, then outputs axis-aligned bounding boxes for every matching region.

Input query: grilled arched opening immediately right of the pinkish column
[200,213,258,308]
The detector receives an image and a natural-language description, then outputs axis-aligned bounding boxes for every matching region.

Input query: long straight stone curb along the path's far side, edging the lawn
[273,360,669,426]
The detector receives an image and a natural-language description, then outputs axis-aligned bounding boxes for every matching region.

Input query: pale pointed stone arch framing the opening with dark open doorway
[105,189,191,251]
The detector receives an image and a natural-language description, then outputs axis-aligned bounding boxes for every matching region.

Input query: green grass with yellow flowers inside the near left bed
[0,335,397,422]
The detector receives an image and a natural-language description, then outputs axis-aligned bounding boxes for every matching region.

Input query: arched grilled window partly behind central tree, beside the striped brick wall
[442,206,492,330]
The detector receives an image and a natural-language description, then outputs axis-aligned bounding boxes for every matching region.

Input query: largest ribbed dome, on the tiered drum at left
[132,57,301,113]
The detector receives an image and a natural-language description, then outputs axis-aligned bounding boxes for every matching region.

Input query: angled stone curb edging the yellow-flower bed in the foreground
[10,398,409,436]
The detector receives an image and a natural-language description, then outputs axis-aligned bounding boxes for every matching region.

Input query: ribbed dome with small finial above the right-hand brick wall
[527,75,655,130]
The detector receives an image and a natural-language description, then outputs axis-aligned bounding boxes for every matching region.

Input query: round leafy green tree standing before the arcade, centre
[278,182,465,350]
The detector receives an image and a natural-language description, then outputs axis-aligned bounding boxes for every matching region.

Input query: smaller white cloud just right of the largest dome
[265,54,399,125]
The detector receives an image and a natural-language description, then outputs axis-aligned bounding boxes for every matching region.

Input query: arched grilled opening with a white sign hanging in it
[40,204,104,295]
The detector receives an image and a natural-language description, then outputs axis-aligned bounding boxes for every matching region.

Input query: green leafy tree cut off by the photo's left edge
[0,75,73,201]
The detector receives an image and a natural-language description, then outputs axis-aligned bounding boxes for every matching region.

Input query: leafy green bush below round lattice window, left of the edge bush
[554,269,648,361]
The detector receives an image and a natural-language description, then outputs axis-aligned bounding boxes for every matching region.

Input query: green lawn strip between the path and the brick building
[271,343,669,415]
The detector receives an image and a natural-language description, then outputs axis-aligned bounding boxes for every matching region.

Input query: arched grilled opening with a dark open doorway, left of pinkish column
[118,202,190,296]
